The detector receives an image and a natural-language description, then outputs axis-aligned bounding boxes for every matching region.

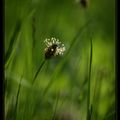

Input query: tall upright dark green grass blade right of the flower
[87,39,93,120]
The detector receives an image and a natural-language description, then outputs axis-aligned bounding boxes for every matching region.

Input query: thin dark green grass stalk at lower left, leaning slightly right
[14,75,23,120]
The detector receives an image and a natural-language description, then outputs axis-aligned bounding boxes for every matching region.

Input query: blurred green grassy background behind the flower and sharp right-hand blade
[5,0,116,120]
